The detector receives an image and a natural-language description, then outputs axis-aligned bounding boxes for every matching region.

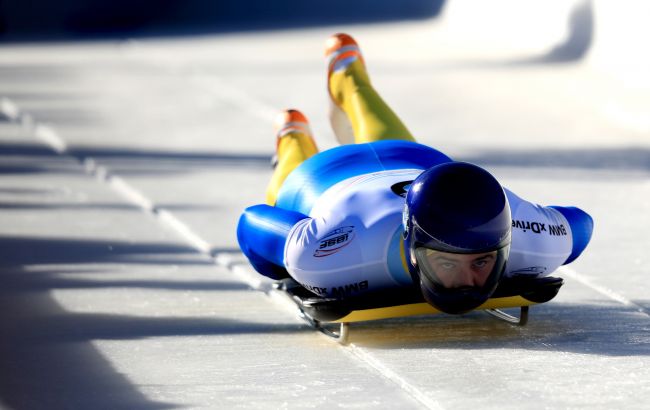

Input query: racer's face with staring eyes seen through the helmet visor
[416,249,497,288]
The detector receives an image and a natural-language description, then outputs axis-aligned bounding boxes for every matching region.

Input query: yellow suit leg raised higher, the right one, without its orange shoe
[329,59,415,144]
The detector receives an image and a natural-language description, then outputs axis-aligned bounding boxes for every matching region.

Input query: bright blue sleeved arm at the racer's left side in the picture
[237,205,308,279]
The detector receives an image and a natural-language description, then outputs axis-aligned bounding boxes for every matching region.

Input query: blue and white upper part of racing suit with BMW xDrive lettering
[237,141,593,297]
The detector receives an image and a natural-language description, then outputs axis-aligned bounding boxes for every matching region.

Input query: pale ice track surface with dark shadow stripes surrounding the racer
[0,1,650,409]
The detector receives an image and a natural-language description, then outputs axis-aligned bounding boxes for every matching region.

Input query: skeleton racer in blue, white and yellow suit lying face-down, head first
[237,34,593,336]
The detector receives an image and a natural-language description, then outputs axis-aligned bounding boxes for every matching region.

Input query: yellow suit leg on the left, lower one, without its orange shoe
[266,132,318,205]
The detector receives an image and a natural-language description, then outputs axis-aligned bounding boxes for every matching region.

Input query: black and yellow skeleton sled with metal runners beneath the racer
[274,277,564,344]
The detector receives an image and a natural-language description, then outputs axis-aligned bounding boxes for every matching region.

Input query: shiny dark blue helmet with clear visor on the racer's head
[403,162,512,314]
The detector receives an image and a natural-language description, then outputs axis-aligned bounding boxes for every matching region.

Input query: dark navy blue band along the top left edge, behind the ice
[0,0,445,38]
